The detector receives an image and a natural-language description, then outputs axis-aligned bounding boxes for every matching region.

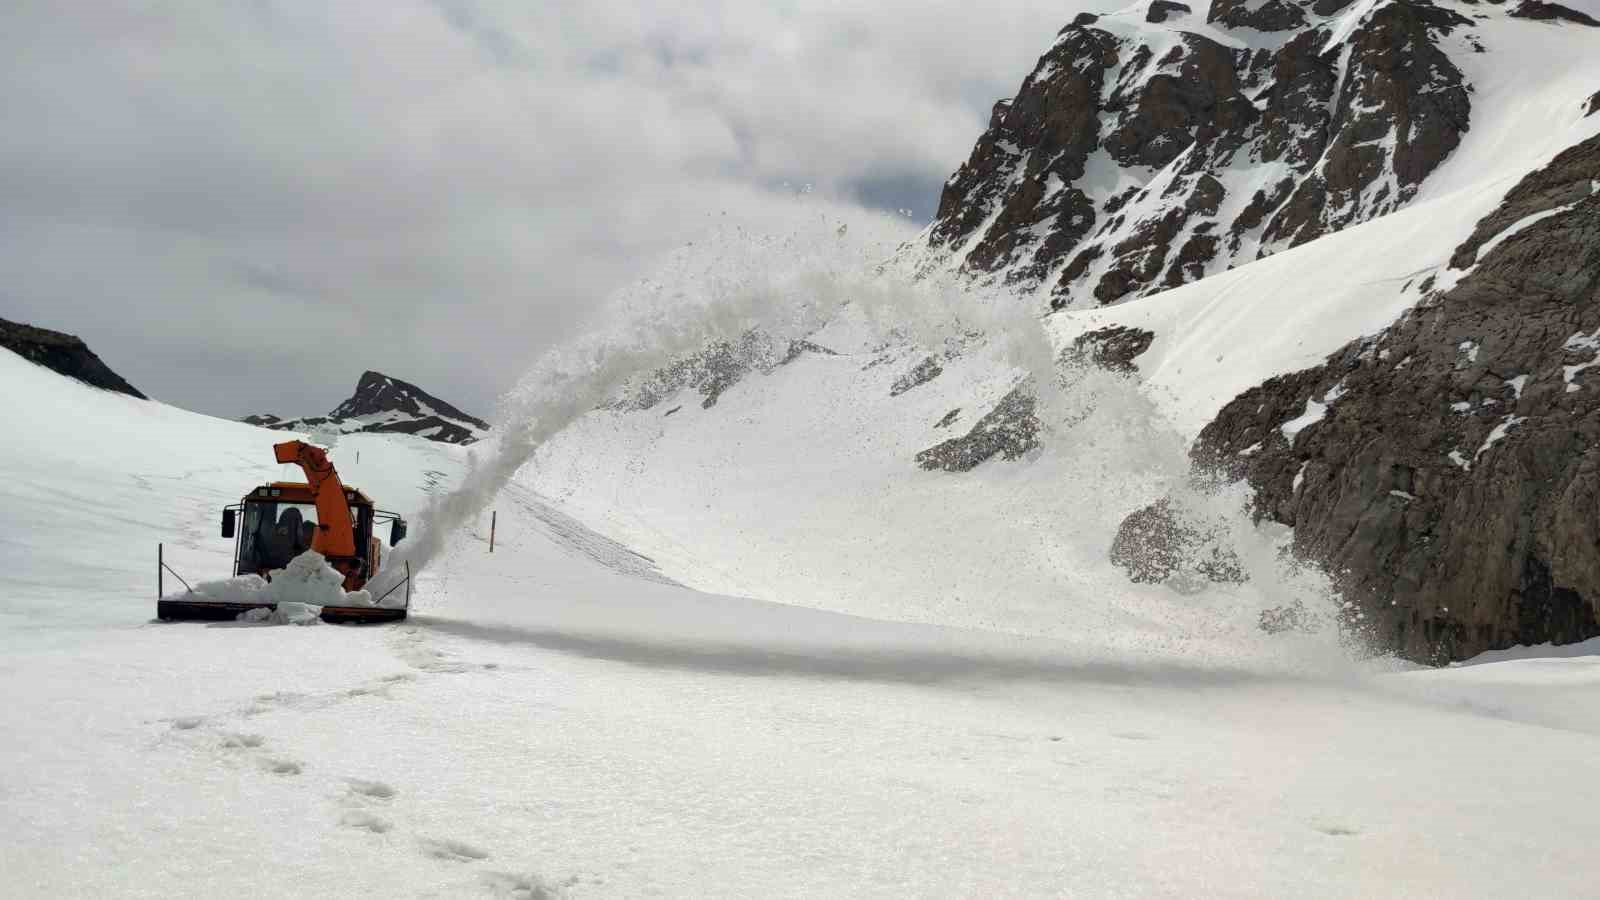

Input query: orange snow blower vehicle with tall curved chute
[157,440,410,621]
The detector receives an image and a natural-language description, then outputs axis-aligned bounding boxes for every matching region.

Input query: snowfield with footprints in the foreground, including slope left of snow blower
[9,312,1600,897]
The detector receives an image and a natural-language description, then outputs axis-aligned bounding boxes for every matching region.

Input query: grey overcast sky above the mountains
[0,0,1123,416]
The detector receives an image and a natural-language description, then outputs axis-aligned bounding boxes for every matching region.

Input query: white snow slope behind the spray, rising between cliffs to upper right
[508,6,1600,643]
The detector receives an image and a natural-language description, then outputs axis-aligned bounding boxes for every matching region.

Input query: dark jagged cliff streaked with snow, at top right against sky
[922,0,1482,307]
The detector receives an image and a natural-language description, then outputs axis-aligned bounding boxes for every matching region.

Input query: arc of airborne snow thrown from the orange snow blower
[378,197,1350,672]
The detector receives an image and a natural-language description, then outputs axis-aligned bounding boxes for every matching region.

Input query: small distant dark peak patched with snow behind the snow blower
[243,372,490,444]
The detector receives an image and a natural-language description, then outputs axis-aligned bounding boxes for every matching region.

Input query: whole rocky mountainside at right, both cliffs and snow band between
[906,0,1600,661]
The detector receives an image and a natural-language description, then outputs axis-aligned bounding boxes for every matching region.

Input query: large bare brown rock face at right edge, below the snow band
[1195,136,1600,661]
